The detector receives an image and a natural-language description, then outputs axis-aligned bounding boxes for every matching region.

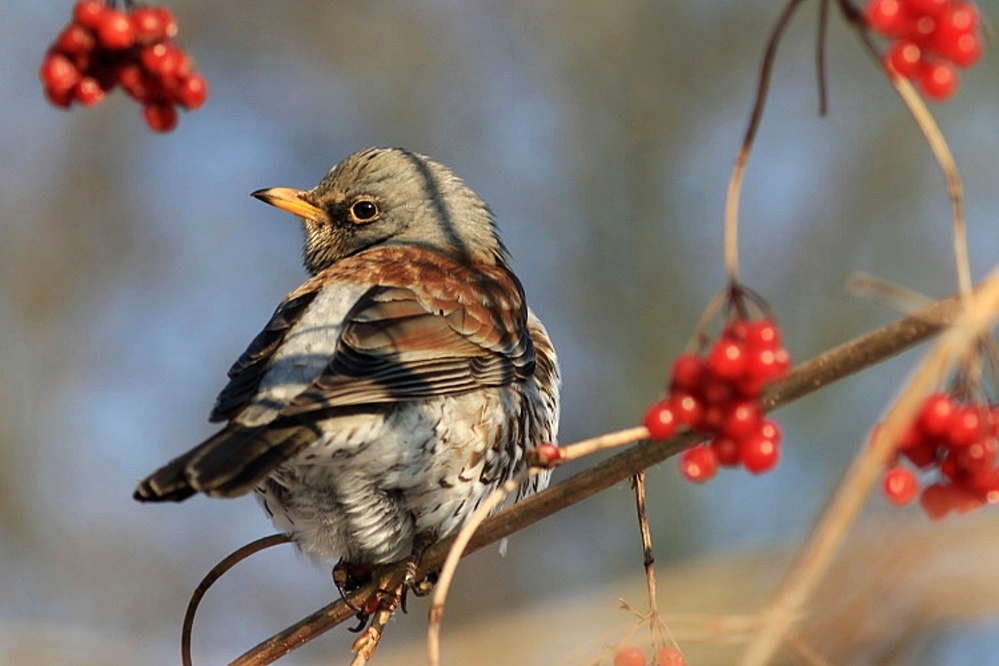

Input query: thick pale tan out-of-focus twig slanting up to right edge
[741,268,999,666]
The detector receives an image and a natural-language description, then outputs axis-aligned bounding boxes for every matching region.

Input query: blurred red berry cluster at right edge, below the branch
[882,393,999,519]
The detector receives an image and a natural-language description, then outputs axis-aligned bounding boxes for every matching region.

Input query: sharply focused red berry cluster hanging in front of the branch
[645,319,791,482]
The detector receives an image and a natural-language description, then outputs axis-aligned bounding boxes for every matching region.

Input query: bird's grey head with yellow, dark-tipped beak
[253,148,506,275]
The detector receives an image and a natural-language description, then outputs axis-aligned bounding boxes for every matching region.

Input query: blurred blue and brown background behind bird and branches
[0,0,999,665]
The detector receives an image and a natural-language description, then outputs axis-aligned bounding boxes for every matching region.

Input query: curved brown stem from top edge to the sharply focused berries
[725,0,802,283]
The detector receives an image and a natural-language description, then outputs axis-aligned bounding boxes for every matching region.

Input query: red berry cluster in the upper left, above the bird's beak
[40,0,208,132]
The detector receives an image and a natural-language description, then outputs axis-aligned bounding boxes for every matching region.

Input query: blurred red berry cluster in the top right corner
[864,0,982,102]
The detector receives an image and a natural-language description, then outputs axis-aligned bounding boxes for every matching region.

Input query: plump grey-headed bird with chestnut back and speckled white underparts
[134,148,560,576]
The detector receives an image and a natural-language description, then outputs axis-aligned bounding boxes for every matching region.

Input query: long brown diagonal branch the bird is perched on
[231,288,960,666]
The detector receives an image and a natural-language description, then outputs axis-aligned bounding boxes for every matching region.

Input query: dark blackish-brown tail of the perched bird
[132,423,316,502]
